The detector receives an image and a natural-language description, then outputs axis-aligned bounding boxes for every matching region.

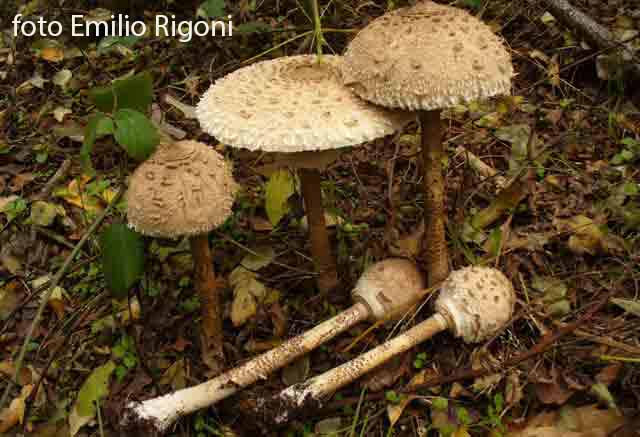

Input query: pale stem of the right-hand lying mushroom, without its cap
[272,313,449,424]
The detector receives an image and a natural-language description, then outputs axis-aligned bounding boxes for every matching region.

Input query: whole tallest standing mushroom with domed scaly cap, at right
[341,1,513,286]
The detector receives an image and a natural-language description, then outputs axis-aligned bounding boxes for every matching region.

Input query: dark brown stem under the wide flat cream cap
[299,168,338,293]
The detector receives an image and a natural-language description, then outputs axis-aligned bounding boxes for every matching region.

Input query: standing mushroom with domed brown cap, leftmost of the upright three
[127,141,237,373]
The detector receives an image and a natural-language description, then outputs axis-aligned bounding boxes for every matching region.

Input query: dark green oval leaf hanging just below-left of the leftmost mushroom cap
[100,224,144,298]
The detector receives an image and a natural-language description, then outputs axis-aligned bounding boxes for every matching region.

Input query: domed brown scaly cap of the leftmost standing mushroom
[127,140,238,238]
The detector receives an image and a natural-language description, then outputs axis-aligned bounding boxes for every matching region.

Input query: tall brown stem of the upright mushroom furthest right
[419,110,449,287]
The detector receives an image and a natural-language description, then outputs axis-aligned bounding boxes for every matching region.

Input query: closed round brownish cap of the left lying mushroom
[353,258,427,320]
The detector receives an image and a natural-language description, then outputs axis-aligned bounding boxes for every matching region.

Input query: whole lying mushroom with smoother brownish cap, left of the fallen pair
[122,258,428,435]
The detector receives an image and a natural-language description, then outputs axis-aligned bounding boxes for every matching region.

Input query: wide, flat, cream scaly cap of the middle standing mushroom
[196,55,411,153]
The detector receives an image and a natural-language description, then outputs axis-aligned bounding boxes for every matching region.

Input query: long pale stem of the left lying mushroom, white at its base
[123,302,370,435]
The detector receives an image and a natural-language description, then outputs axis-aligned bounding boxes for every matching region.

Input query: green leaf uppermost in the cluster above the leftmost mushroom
[89,71,153,112]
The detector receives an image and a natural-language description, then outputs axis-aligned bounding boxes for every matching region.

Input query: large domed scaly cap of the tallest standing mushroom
[341,1,513,110]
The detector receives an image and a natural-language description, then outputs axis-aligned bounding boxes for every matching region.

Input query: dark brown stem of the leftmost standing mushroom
[189,234,224,373]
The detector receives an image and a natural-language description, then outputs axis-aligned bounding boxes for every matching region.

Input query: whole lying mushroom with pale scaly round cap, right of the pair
[268,267,515,424]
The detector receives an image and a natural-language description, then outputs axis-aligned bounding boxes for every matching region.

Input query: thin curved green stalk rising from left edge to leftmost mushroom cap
[0,185,125,409]
